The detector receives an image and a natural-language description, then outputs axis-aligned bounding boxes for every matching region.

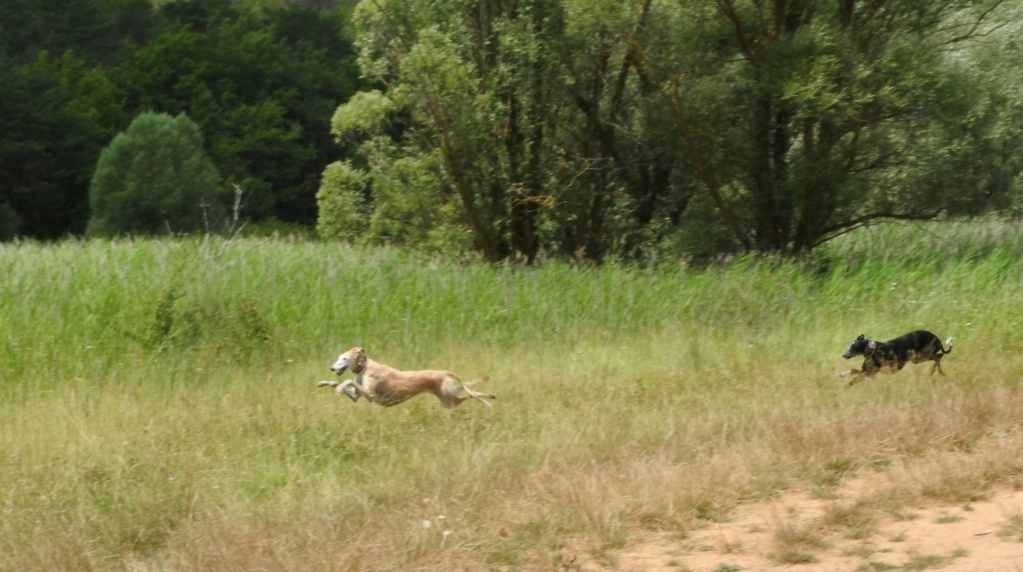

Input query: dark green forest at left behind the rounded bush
[0,0,359,238]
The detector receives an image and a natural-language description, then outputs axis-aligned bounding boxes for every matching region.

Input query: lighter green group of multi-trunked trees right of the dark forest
[320,0,1023,260]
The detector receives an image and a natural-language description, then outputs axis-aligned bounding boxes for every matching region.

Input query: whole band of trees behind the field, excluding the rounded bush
[0,0,1023,261]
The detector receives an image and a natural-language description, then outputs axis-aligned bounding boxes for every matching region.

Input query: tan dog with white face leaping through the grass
[317,348,497,407]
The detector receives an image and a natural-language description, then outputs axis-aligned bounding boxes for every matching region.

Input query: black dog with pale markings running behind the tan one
[842,329,952,386]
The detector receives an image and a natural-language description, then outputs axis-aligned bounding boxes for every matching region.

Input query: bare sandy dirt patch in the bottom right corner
[569,479,1023,572]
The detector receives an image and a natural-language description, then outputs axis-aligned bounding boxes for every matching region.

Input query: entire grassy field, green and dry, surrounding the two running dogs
[0,220,1023,571]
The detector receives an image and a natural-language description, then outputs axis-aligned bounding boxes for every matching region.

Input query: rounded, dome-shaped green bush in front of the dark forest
[87,113,225,235]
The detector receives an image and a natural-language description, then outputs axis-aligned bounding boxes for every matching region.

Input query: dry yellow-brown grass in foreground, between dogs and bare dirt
[2,339,1023,570]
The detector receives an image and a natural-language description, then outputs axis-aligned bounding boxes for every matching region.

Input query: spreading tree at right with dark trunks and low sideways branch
[644,0,1006,253]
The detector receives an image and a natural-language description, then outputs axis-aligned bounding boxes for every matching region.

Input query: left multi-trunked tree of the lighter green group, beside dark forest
[333,0,692,261]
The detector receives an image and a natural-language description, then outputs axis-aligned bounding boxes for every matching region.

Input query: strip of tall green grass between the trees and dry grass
[0,218,1023,389]
